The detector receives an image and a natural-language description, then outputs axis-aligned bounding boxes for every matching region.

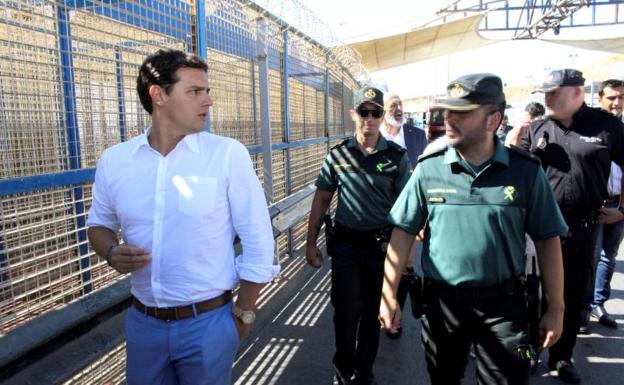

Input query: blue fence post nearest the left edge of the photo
[56,2,92,294]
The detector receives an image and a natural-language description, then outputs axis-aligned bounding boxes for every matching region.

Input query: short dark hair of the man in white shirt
[137,49,208,115]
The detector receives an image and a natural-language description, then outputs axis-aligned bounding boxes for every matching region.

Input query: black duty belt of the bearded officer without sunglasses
[425,277,526,302]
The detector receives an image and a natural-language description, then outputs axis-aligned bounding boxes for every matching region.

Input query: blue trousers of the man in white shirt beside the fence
[125,302,239,385]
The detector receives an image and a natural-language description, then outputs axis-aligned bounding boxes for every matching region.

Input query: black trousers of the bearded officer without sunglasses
[421,283,531,385]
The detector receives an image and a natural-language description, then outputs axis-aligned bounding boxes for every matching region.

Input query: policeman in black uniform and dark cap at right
[508,69,624,383]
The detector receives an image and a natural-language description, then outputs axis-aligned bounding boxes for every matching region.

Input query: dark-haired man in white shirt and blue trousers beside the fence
[87,50,279,385]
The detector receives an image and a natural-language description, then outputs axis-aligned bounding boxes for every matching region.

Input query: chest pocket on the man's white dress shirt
[172,175,217,217]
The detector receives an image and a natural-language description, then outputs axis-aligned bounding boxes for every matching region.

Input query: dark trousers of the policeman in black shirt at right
[548,221,599,364]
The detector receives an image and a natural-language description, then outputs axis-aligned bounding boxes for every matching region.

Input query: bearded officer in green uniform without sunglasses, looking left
[379,74,567,385]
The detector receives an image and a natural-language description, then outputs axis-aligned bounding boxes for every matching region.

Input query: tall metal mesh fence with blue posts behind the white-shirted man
[0,0,358,383]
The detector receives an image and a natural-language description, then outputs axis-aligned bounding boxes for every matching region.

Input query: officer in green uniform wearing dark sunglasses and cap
[306,87,410,385]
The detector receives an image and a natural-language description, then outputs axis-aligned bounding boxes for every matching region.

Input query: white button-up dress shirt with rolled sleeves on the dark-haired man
[87,132,279,307]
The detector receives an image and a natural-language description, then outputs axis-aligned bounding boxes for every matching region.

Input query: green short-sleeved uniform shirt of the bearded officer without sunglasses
[389,140,567,287]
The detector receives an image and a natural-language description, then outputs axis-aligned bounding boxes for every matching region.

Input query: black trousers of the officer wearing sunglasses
[330,237,385,378]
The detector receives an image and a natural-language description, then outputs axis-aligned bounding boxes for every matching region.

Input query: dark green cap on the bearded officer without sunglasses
[435,73,505,111]
